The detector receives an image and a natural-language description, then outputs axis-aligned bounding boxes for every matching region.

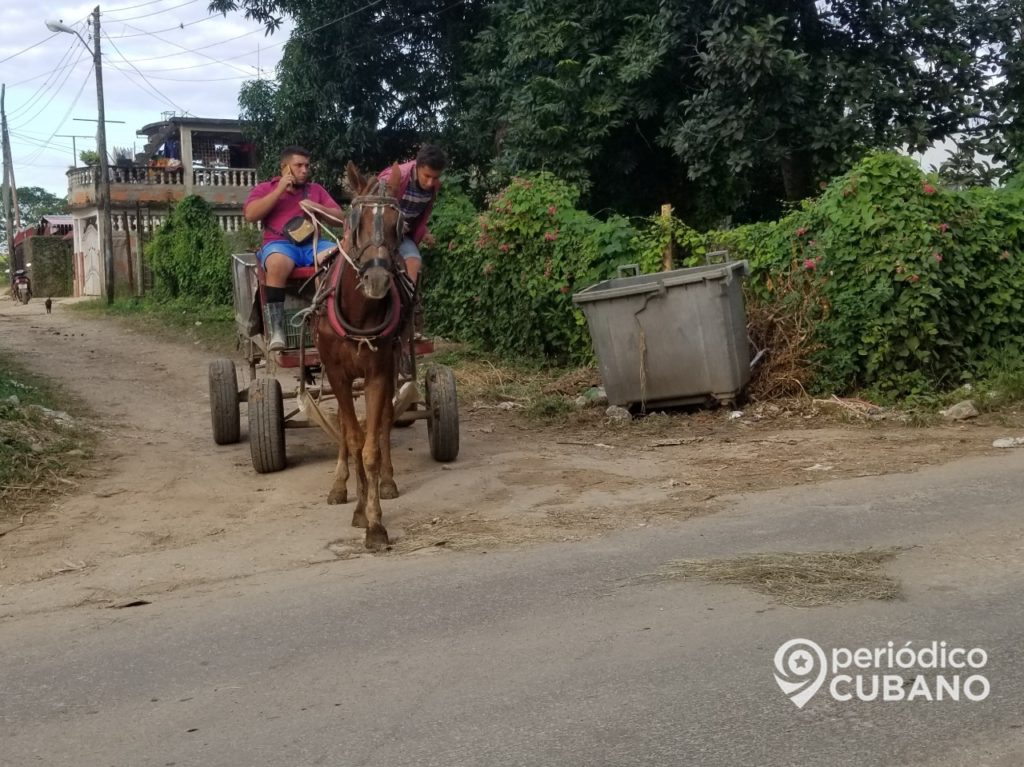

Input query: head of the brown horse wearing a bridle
[345,162,403,300]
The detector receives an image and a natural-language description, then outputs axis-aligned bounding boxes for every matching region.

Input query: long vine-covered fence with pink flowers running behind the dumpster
[426,154,1024,394]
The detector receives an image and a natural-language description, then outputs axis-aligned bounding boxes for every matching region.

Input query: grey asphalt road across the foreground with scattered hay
[0,453,1024,767]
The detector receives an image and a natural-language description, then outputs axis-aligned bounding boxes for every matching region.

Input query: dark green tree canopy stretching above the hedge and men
[210,0,1024,220]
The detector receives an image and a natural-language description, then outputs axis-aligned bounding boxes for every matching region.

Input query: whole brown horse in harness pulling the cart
[313,163,407,549]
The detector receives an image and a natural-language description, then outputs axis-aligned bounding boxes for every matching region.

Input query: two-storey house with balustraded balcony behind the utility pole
[68,113,256,296]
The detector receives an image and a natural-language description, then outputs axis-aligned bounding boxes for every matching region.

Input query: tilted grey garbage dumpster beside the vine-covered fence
[572,261,751,407]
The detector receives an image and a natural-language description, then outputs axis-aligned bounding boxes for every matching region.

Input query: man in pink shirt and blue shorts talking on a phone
[243,146,341,351]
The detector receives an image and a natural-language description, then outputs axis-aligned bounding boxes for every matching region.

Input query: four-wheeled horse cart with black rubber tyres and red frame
[209,248,459,473]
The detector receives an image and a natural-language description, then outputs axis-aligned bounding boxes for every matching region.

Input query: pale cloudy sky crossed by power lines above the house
[0,0,291,197]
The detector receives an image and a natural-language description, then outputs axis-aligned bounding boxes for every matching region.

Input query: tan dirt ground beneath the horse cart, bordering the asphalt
[0,298,1021,619]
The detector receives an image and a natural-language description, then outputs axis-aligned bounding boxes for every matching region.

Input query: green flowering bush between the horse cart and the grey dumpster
[426,173,636,363]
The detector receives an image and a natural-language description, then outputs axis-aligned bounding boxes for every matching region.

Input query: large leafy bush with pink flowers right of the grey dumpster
[712,154,1024,398]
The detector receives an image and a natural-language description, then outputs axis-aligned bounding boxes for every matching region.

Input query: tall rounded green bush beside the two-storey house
[145,195,231,304]
